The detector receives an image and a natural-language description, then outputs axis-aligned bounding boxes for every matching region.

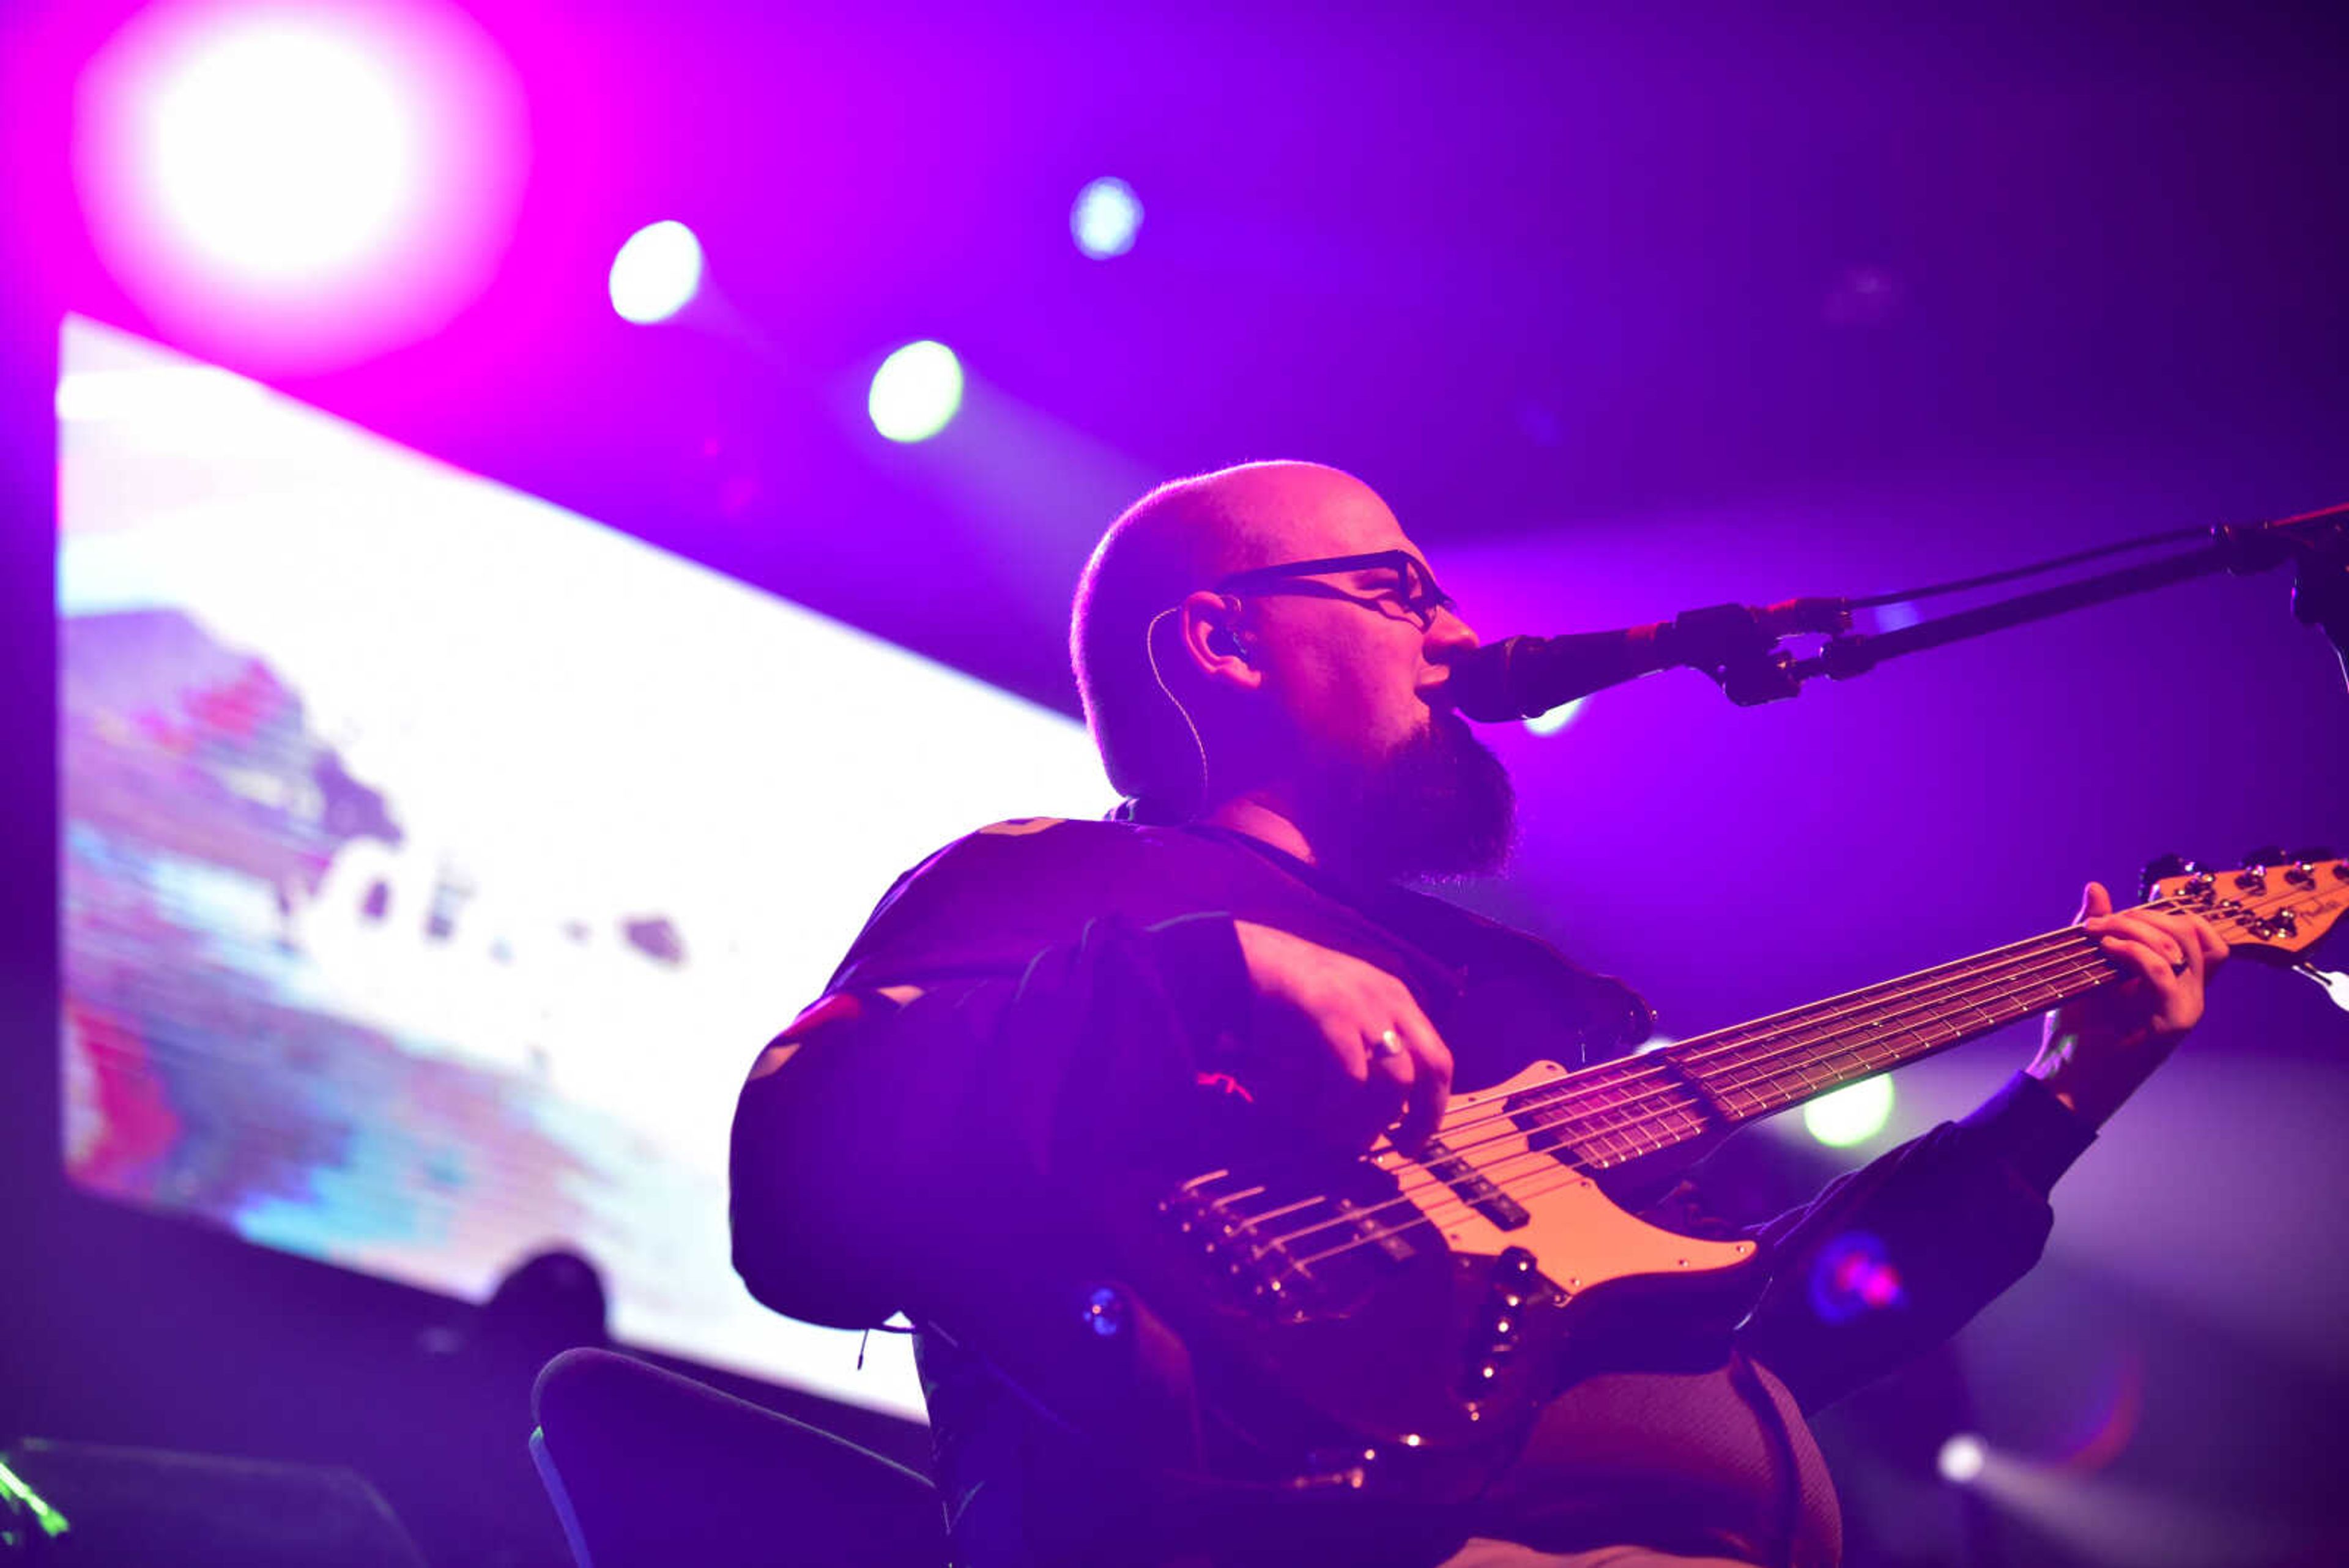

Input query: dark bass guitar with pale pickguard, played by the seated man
[1083,856,2349,1502]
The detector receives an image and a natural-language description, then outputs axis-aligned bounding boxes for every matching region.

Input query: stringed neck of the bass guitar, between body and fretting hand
[1518,926,2123,1171]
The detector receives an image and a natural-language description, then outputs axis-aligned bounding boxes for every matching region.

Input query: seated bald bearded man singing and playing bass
[733,463,2224,1568]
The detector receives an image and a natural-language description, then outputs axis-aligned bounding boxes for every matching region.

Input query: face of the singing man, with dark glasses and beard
[1231,480,1515,877]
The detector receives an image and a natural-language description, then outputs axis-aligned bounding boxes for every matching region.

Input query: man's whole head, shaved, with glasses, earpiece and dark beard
[1069,463,1515,879]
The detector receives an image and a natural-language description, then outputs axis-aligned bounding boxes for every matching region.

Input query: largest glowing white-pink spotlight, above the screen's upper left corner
[75,0,529,369]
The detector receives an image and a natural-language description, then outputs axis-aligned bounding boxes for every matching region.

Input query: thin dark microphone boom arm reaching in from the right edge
[1708,505,2349,705]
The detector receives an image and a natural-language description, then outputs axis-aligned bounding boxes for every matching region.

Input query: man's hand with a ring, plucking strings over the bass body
[1233,919,1452,1154]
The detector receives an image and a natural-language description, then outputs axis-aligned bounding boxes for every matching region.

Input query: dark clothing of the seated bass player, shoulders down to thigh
[733,818,2091,1568]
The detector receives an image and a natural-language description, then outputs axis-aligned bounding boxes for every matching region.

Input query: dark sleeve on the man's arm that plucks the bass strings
[730,893,1247,1326]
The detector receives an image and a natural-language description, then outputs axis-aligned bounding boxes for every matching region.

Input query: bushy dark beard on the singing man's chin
[1327,710,1518,882]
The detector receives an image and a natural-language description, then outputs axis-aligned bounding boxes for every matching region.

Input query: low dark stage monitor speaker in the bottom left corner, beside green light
[0,1436,425,1568]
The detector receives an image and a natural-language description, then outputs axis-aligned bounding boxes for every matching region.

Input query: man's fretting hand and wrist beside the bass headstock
[2030,882,2227,1126]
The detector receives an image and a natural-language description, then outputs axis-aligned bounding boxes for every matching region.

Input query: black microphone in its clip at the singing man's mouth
[1445,600,1851,724]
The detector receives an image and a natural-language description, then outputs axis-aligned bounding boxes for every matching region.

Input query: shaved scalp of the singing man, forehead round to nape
[1069,461,1402,804]
